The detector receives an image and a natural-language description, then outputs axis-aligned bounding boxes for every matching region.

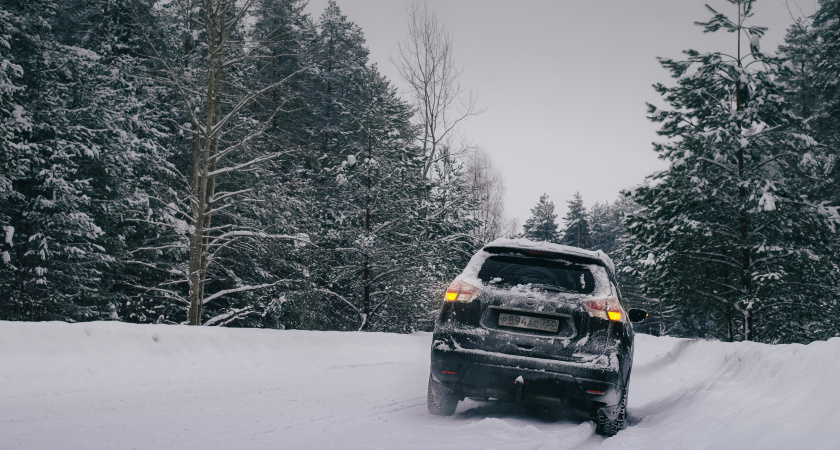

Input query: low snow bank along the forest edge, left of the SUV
[0,321,426,395]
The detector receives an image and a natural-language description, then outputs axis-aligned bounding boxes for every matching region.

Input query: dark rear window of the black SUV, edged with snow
[478,256,595,294]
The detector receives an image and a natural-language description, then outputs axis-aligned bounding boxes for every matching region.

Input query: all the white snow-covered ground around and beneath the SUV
[0,322,840,449]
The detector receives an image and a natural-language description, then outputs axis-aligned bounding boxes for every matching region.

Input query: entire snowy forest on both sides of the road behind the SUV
[0,0,840,343]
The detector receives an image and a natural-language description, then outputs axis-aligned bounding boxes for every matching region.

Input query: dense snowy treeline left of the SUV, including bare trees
[0,0,503,332]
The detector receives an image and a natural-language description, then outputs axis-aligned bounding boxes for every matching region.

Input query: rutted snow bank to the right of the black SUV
[619,335,840,449]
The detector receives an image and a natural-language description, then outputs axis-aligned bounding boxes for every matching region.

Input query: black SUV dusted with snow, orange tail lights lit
[427,239,647,436]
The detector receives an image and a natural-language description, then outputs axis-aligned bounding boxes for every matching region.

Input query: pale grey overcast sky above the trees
[308,0,816,228]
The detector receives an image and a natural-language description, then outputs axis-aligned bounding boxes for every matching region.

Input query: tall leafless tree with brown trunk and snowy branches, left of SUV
[143,0,306,325]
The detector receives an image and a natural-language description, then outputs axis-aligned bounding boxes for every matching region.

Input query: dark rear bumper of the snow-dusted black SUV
[431,349,624,415]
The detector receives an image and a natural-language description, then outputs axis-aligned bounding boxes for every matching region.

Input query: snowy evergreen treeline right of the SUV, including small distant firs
[525,0,840,343]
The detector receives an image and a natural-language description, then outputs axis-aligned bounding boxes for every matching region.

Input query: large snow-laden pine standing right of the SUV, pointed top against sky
[625,0,837,342]
